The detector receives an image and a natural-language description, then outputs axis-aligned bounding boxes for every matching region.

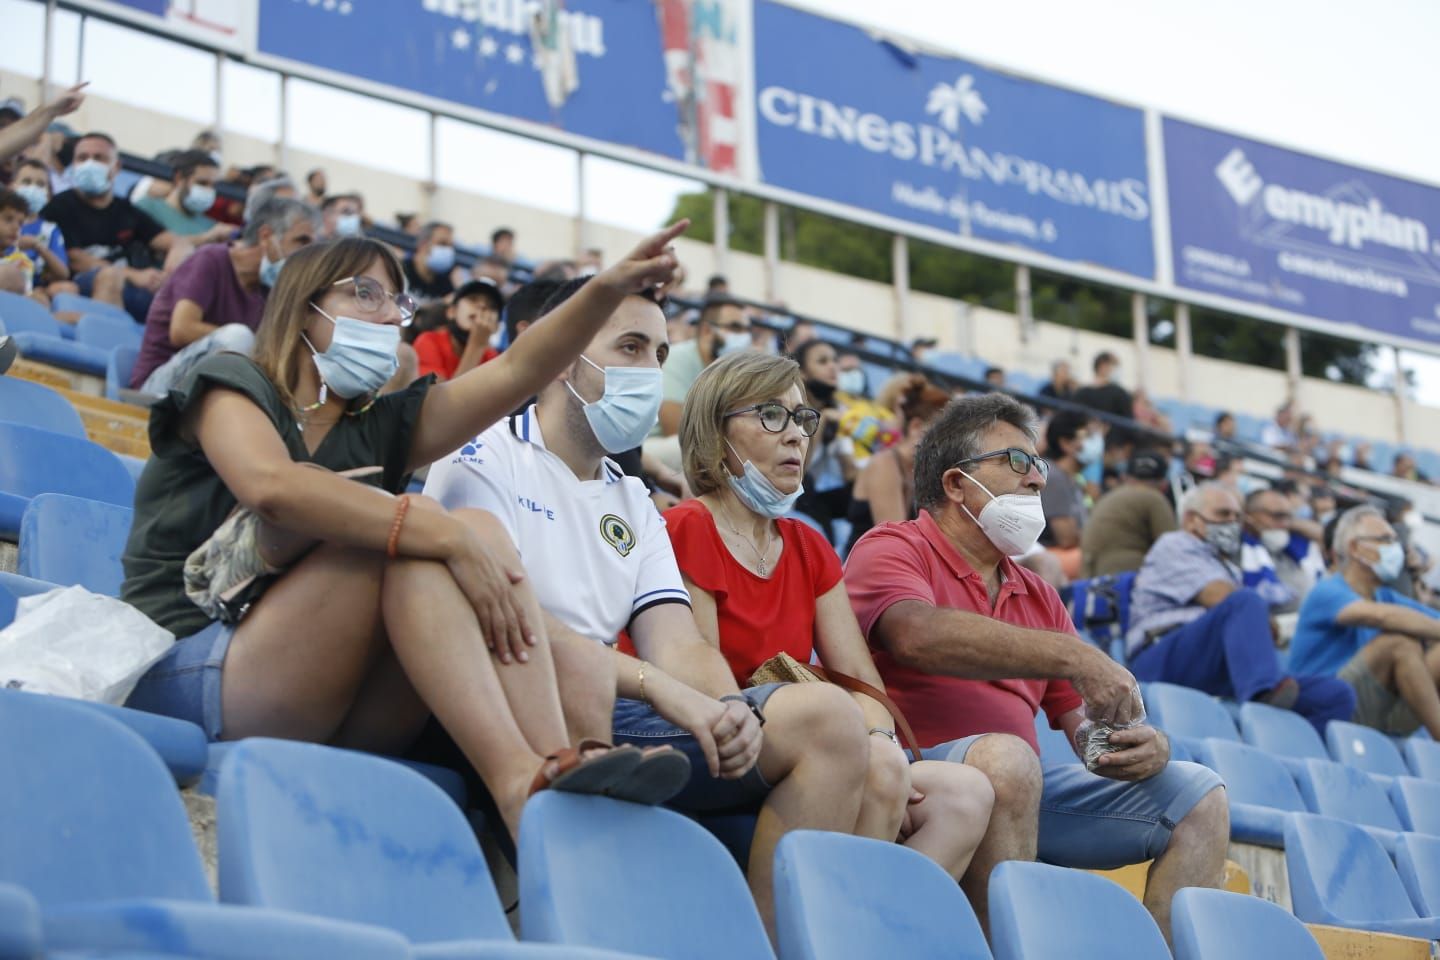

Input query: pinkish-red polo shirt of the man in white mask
[845,511,1083,753]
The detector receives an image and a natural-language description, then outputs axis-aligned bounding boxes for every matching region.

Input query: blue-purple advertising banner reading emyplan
[1164,118,1440,343]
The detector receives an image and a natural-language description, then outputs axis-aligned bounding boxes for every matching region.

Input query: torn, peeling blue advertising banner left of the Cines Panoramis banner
[256,0,743,173]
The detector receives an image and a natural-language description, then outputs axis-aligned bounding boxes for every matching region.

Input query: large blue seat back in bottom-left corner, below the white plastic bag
[0,689,212,907]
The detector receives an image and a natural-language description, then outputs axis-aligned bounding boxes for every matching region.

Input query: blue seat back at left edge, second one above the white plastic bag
[0,420,135,507]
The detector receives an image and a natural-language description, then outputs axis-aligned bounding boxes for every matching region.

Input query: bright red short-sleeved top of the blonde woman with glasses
[665,499,841,687]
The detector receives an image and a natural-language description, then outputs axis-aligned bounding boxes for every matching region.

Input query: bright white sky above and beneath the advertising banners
[0,0,1440,406]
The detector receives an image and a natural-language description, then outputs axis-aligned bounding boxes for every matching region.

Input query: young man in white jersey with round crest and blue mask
[425,279,868,924]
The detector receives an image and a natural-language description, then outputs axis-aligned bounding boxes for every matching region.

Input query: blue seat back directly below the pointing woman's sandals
[520,790,775,960]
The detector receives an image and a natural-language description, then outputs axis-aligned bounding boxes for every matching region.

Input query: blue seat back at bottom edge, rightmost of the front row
[1171,887,1325,960]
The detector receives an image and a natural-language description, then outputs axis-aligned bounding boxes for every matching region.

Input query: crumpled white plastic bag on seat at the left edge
[0,587,176,705]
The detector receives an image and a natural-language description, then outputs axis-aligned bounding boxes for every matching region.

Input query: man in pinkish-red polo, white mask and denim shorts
[845,393,1230,938]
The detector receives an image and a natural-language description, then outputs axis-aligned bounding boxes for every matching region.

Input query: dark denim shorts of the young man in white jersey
[612,684,785,813]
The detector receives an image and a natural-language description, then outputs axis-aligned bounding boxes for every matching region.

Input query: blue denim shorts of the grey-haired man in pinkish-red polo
[920,734,1224,869]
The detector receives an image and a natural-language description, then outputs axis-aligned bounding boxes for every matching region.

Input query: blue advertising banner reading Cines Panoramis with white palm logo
[755,0,1155,278]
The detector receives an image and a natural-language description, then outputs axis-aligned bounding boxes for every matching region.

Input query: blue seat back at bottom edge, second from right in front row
[990,861,1169,960]
